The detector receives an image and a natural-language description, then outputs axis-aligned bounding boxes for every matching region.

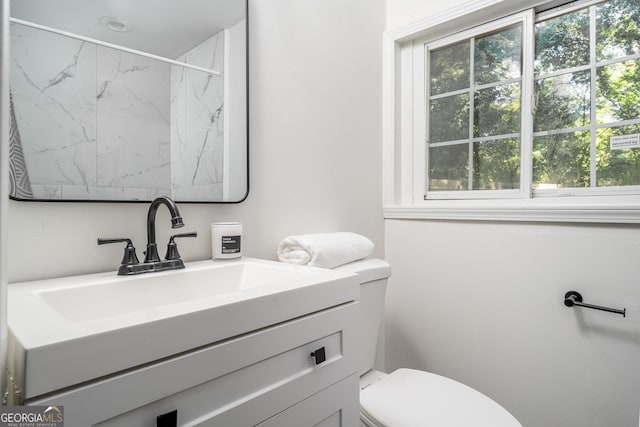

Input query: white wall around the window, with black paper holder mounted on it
[385,0,640,427]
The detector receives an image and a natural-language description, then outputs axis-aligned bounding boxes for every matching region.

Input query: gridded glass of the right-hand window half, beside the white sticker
[532,0,640,194]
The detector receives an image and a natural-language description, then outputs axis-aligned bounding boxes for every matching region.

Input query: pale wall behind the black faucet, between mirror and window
[8,0,385,281]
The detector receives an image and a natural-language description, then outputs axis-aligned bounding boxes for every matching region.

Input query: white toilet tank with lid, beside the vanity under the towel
[335,258,391,375]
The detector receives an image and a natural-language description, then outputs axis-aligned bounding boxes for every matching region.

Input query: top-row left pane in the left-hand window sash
[429,40,470,95]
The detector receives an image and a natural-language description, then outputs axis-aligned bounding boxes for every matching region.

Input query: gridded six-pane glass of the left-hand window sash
[425,23,523,197]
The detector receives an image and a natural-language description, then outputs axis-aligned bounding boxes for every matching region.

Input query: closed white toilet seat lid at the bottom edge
[360,369,522,427]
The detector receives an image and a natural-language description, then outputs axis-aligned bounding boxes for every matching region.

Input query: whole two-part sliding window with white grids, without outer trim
[412,0,640,203]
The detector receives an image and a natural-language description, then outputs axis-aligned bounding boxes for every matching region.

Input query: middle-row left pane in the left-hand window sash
[429,93,469,142]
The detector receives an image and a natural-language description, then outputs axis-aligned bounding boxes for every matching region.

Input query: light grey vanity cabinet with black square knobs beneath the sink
[26,301,359,427]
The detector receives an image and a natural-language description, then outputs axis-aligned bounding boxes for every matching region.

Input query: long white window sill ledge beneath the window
[384,196,640,224]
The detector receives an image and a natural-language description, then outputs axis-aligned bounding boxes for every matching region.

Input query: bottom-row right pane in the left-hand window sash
[473,138,520,190]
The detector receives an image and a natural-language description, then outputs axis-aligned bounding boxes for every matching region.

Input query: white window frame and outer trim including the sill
[383,0,640,223]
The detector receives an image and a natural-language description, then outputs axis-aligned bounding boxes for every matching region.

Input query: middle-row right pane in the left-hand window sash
[473,83,520,137]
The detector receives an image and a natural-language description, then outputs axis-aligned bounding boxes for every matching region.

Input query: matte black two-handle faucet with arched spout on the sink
[98,196,197,276]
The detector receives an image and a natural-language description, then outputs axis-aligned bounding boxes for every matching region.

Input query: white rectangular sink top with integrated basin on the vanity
[8,258,359,402]
